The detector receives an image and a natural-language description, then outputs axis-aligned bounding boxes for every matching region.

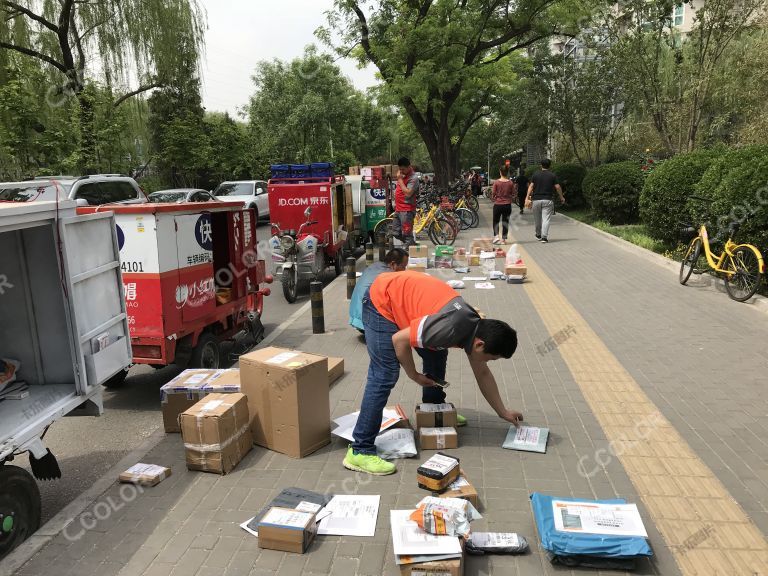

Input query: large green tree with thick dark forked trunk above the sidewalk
[328,0,578,184]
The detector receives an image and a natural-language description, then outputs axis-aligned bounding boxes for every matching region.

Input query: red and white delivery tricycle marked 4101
[78,202,272,387]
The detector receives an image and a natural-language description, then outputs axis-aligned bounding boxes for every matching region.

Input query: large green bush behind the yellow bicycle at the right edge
[686,145,768,252]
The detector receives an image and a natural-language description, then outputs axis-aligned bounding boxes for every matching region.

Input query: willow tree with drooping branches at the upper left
[0,0,204,171]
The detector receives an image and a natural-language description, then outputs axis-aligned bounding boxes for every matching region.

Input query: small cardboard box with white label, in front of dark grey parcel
[258,507,317,554]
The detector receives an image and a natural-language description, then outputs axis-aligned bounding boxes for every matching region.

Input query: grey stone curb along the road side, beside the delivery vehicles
[0,256,356,576]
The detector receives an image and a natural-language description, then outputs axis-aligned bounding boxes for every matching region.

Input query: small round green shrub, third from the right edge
[582,162,643,224]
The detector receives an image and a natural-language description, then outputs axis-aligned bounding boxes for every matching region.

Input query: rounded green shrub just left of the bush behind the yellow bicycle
[640,148,725,244]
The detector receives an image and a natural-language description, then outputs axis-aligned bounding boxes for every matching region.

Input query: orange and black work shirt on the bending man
[370,271,480,354]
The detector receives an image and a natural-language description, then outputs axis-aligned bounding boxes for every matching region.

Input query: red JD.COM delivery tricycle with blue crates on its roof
[267,168,363,303]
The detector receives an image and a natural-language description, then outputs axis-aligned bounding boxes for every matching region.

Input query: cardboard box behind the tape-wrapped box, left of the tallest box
[160,369,240,434]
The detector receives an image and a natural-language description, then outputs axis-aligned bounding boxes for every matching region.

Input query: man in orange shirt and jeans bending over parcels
[344,271,523,476]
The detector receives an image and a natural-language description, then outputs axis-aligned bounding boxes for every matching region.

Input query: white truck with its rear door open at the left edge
[0,200,131,558]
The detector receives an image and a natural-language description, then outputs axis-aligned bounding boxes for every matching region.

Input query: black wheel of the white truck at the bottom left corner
[0,465,41,558]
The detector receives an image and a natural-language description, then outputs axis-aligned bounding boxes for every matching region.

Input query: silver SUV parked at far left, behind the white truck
[0,174,147,206]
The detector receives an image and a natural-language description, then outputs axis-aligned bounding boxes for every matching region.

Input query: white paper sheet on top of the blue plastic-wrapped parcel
[552,500,648,538]
